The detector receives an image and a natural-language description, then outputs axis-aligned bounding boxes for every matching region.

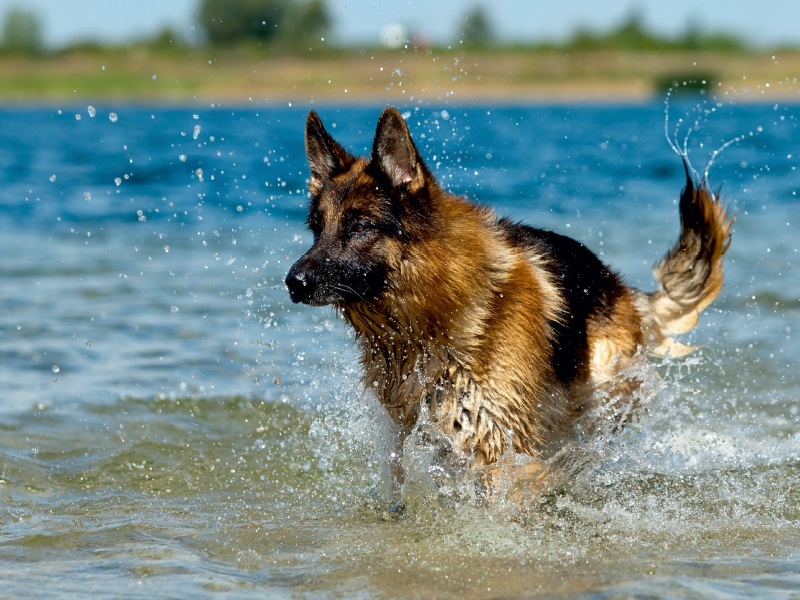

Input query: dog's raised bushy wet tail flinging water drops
[640,159,733,356]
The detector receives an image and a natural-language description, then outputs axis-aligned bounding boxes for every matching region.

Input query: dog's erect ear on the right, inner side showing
[372,108,425,190]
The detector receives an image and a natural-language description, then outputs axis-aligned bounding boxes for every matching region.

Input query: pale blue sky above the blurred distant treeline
[0,0,800,47]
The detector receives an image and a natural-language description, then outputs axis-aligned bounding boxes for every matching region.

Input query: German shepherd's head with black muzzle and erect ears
[286,108,436,306]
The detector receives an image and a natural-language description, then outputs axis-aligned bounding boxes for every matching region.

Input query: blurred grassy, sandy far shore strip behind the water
[0,49,800,107]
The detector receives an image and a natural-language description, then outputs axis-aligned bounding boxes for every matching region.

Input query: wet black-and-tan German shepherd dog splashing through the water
[286,108,732,467]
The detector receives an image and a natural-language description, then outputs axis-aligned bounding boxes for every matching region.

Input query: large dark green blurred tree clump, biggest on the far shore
[198,0,331,46]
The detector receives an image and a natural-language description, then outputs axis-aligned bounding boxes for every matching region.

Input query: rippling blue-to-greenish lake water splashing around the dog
[0,101,800,598]
